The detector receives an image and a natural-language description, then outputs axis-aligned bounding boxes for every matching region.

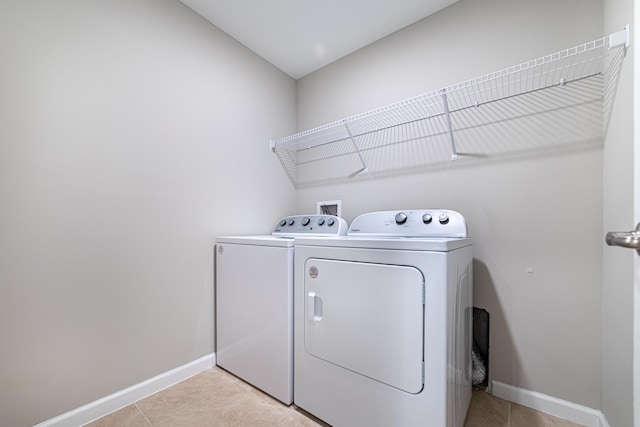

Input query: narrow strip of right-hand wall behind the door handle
[602,0,640,426]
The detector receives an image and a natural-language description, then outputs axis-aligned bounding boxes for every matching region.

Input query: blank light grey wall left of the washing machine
[0,0,295,427]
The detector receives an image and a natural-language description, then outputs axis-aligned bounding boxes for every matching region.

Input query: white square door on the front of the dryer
[304,258,424,393]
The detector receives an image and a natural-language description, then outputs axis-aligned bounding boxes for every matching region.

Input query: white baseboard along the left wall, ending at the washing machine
[34,353,216,427]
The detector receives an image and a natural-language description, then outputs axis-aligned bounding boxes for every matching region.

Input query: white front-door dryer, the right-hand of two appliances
[294,209,473,427]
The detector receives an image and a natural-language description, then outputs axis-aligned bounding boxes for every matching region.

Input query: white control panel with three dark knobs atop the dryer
[347,209,469,238]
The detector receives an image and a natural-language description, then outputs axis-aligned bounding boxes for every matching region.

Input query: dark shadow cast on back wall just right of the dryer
[473,258,521,387]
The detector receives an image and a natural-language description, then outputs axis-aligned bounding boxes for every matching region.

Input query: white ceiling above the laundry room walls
[180,0,458,79]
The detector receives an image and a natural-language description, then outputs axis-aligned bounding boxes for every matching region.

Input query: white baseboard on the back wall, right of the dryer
[491,381,609,427]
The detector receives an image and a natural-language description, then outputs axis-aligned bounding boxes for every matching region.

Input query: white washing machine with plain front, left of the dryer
[216,215,347,405]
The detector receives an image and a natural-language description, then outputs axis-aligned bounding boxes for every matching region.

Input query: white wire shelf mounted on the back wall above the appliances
[270,26,629,186]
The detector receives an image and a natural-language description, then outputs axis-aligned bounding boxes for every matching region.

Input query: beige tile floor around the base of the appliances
[87,368,577,427]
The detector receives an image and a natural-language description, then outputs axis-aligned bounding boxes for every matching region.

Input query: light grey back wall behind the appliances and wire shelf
[297,0,604,408]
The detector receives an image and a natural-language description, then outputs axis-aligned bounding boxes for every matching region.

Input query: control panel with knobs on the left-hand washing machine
[271,215,348,236]
